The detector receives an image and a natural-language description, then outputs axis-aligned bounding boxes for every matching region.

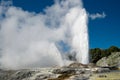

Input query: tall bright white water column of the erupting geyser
[71,9,89,64]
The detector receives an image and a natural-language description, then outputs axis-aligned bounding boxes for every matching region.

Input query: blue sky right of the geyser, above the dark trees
[84,0,120,48]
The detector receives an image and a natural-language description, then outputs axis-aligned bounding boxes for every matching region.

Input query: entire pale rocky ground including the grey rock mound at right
[0,52,120,80]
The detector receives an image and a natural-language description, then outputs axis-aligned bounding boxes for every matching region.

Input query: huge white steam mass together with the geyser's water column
[0,0,88,69]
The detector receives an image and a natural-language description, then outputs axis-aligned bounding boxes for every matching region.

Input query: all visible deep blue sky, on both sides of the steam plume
[3,0,120,48]
